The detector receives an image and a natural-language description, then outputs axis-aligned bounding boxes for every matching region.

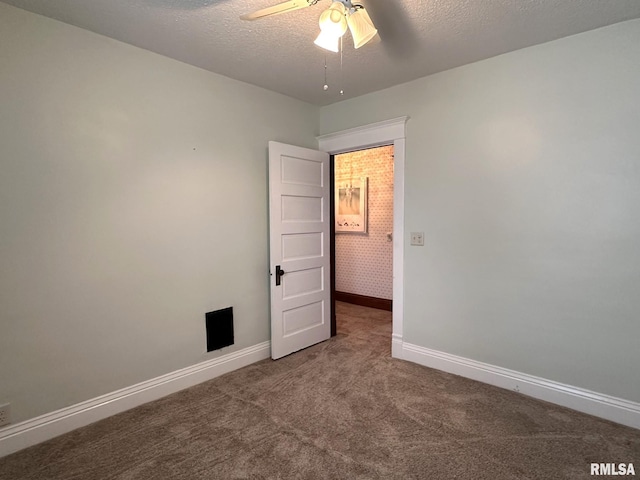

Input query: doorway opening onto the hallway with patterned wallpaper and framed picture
[331,144,394,335]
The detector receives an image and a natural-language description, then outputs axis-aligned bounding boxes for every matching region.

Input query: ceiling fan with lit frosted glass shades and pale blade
[240,0,378,52]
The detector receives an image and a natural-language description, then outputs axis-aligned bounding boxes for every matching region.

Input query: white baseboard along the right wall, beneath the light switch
[404,343,640,429]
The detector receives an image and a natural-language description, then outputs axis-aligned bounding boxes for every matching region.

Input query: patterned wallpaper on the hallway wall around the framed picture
[335,145,393,300]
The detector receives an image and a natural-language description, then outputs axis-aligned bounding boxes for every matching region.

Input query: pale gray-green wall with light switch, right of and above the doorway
[321,20,640,402]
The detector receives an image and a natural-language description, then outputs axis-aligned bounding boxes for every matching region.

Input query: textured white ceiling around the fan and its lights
[2,0,640,105]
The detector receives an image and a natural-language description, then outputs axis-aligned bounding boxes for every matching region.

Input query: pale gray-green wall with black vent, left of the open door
[0,3,318,421]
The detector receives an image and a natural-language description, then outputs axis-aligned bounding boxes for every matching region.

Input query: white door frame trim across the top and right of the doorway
[316,117,409,358]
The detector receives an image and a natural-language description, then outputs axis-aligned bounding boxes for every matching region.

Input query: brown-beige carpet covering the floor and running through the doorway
[0,303,640,480]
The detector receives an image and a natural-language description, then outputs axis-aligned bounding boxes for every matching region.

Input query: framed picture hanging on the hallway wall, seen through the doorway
[335,177,367,233]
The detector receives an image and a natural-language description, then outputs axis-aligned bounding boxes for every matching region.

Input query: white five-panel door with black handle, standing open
[269,142,331,360]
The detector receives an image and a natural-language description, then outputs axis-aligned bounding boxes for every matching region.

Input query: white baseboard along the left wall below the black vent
[0,342,271,458]
